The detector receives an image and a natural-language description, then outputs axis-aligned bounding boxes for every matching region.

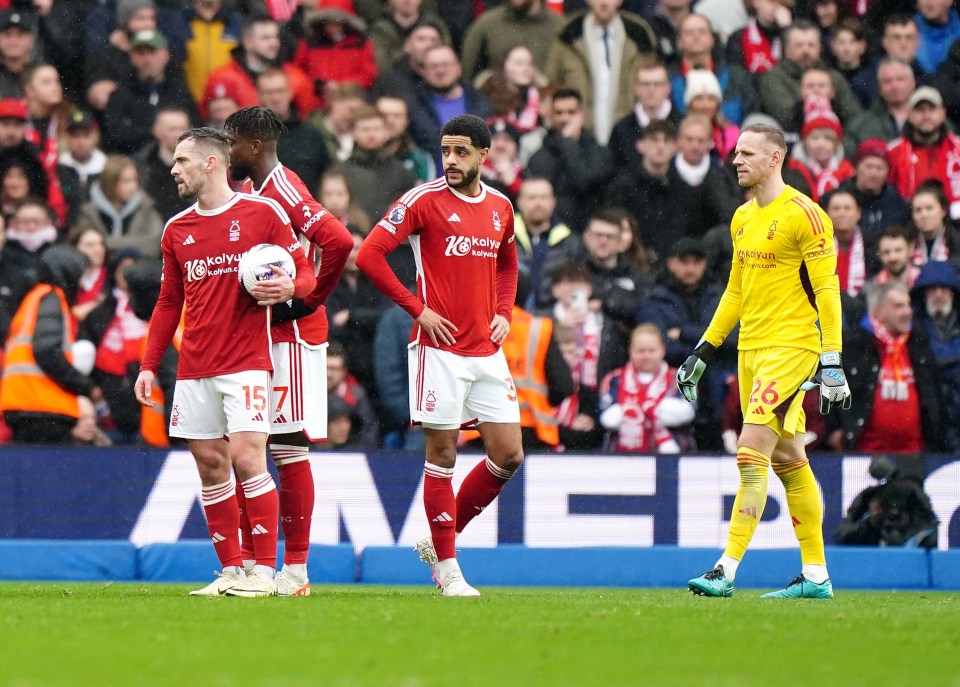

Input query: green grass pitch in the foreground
[0,583,960,687]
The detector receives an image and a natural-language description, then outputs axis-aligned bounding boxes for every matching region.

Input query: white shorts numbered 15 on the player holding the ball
[170,370,270,439]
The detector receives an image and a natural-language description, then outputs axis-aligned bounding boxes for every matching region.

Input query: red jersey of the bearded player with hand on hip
[373,177,517,356]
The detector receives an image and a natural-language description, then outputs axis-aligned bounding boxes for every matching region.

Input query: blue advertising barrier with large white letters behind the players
[0,447,960,589]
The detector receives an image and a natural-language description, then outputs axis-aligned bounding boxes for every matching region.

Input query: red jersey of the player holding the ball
[141,193,313,379]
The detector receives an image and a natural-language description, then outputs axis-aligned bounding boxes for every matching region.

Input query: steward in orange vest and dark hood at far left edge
[0,246,103,443]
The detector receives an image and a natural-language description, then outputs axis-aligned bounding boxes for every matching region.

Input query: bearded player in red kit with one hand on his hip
[357,115,523,596]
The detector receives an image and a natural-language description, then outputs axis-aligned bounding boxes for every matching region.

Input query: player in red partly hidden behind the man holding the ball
[224,105,353,596]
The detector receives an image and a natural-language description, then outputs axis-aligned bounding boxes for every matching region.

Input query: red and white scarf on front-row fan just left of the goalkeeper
[617,362,673,453]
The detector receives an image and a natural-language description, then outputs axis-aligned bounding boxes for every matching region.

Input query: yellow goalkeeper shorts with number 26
[737,348,820,439]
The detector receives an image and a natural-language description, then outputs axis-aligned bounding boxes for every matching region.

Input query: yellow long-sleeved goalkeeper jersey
[704,186,841,354]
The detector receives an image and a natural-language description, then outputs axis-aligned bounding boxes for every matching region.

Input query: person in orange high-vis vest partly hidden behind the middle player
[460,296,573,449]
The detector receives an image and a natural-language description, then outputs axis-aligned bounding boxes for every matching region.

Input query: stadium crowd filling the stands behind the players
[0,0,960,453]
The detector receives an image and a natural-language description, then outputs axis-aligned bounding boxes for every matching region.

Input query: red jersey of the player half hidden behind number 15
[240,164,353,345]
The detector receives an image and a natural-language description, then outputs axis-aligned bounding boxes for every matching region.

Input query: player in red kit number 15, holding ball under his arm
[135,127,317,596]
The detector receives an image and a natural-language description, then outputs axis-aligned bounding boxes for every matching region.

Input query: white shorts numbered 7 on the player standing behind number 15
[270,342,327,441]
